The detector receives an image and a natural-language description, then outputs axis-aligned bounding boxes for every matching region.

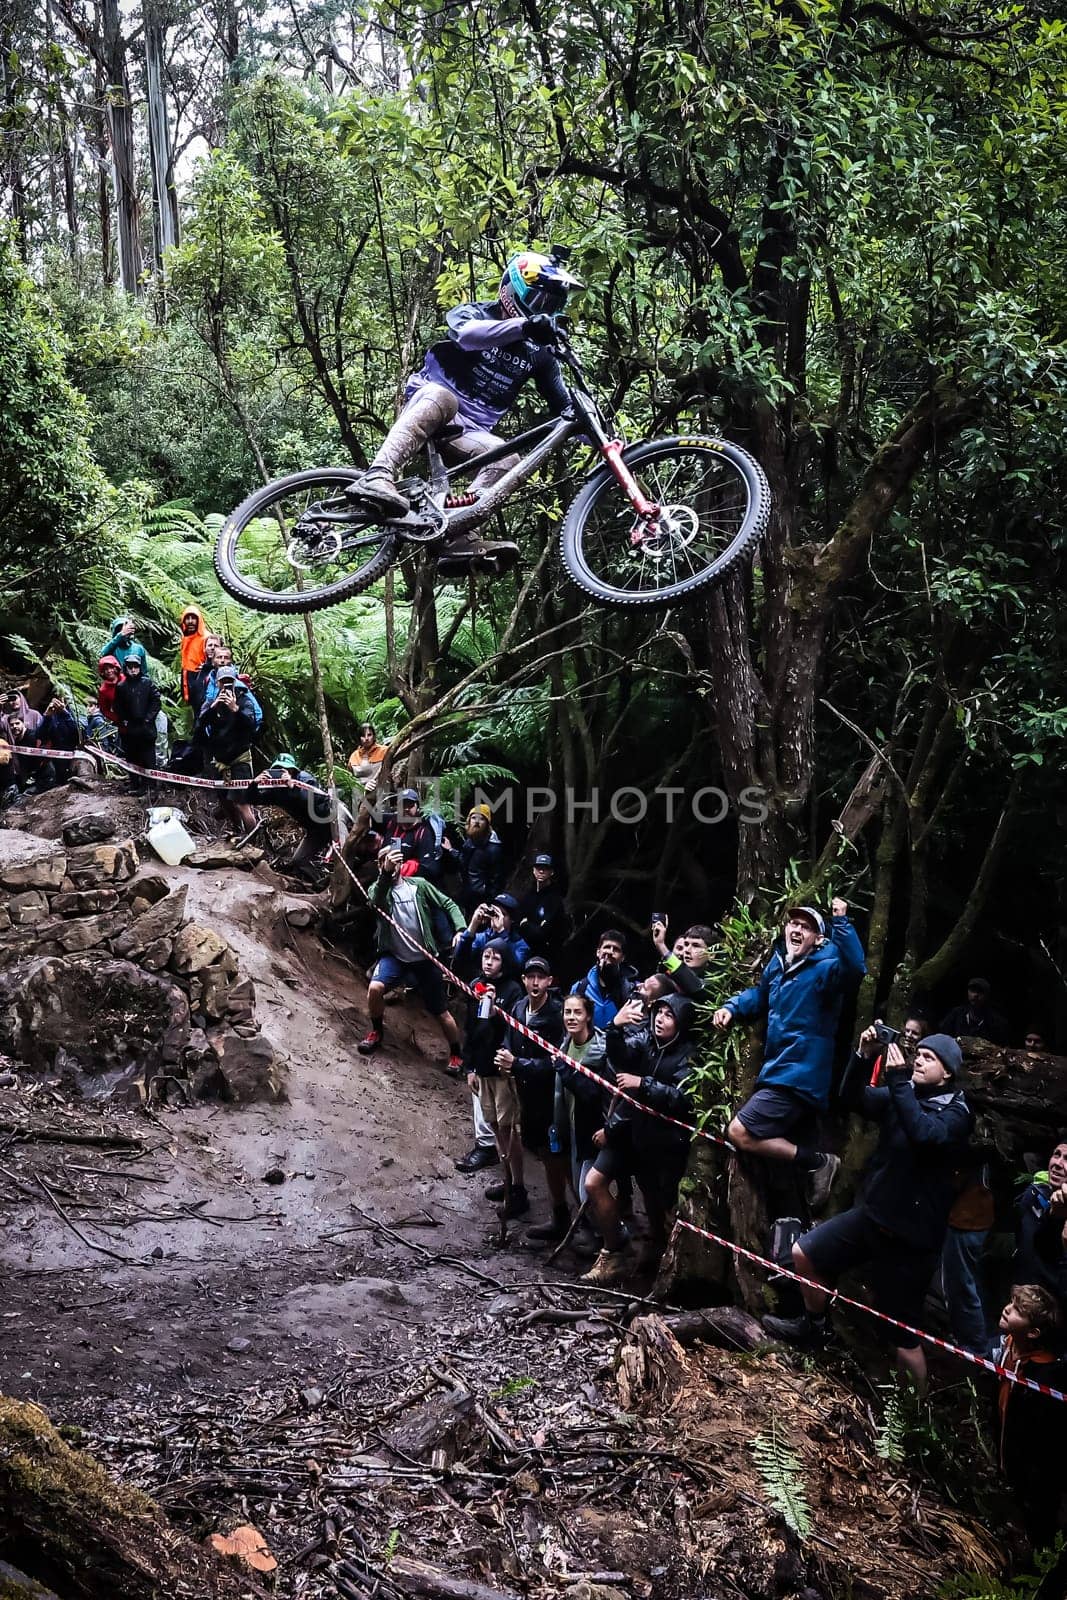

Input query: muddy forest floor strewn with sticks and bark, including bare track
[0,792,1023,1600]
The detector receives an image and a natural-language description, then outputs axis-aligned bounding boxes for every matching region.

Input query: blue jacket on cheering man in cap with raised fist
[723,917,867,1109]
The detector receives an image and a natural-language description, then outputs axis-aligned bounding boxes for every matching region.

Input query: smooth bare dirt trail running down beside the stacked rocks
[0,832,550,1413]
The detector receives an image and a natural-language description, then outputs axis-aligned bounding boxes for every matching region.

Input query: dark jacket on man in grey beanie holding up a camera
[843,1062,974,1250]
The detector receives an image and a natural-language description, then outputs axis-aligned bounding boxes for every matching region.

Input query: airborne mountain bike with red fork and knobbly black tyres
[214,330,771,613]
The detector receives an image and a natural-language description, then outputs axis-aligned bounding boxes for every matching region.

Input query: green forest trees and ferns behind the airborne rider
[0,0,1067,1032]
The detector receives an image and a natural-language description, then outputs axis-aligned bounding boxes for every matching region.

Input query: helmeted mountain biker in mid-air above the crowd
[347,250,582,555]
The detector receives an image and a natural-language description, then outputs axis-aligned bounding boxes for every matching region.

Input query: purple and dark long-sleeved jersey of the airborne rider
[405,301,569,432]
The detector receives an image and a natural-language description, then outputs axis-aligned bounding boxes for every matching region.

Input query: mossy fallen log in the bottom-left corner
[0,1395,267,1600]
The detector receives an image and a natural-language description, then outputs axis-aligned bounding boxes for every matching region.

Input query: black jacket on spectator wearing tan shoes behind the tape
[608,995,693,1160]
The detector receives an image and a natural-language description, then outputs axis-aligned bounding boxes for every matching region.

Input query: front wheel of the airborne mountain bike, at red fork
[560,435,771,606]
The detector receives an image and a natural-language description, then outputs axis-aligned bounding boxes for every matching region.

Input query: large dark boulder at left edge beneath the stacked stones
[0,953,189,1083]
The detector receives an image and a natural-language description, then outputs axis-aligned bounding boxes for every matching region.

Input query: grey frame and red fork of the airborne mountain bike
[427,333,659,542]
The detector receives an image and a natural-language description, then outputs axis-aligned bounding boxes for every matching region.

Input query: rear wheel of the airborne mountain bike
[214,467,400,614]
